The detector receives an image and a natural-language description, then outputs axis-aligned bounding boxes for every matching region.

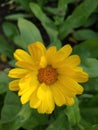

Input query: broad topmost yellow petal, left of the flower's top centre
[28,42,46,61]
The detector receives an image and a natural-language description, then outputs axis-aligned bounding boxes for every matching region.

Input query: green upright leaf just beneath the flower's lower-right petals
[65,98,81,125]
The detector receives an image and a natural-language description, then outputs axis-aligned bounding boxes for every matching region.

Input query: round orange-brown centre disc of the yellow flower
[38,65,58,85]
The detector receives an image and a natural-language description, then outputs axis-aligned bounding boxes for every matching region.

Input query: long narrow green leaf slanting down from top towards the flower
[30,3,58,42]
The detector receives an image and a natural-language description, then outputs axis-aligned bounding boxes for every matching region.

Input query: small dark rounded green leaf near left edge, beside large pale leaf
[2,22,19,39]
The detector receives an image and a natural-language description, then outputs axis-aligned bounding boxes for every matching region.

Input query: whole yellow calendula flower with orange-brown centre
[8,42,88,114]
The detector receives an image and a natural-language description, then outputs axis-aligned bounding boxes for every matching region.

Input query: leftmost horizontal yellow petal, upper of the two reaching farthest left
[8,68,29,78]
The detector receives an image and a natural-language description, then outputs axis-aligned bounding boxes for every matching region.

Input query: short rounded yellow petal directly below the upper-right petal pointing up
[65,55,80,67]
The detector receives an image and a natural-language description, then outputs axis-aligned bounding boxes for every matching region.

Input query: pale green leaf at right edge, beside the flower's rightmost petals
[82,58,98,78]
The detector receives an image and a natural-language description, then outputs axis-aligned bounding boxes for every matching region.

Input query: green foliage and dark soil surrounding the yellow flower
[0,0,98,130]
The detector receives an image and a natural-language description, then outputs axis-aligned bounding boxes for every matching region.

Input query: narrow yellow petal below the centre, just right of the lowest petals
[50,84,65,106]
